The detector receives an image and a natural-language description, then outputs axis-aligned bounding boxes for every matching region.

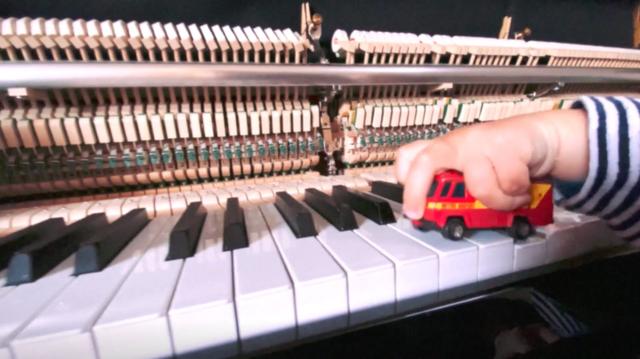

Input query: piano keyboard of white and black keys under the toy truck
[0,172,617,358]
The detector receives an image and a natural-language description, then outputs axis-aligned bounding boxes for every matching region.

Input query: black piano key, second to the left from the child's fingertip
[331,186,396,224]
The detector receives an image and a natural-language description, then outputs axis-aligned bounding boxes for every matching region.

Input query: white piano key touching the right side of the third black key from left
[11,218,167,358]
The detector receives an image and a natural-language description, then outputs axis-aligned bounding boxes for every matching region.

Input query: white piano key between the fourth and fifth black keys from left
[169,211,238,357]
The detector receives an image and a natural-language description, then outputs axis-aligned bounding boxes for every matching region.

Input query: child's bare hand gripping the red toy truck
[396,110,589,219]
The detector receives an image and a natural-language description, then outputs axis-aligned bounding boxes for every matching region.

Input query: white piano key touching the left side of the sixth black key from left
[261,204,349,338]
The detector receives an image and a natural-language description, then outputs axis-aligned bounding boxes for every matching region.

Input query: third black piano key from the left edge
[75,208,149,275]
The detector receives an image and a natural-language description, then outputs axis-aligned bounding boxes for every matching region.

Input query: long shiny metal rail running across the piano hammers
[0,62,640,88]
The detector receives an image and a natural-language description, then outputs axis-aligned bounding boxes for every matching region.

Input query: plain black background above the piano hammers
[0,0,633,47]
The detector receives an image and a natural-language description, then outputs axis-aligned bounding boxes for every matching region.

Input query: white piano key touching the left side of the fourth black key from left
[93,216,183,358]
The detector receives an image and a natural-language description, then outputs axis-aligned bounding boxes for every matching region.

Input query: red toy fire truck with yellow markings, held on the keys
[413,171,553,240]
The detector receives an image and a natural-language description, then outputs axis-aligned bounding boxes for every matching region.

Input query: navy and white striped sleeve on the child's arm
[556,96,640,240]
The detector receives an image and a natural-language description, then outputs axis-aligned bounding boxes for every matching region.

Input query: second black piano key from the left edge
[7,213,109,285]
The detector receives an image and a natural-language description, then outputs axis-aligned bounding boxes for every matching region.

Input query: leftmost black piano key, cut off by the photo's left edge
[0,218,65,270]
